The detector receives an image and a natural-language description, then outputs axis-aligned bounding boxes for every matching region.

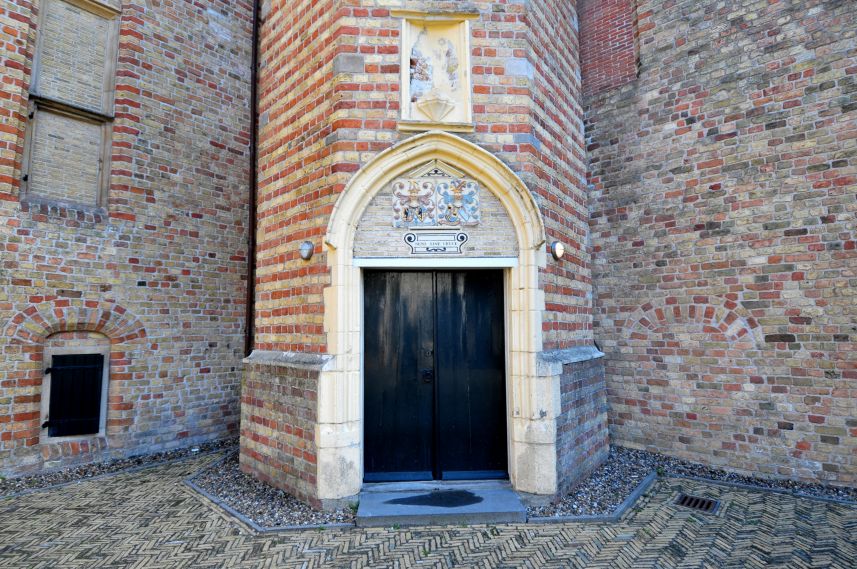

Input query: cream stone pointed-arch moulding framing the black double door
[315,131,560,500]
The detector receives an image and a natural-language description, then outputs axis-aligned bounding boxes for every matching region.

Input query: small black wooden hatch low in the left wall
[47,354,104,437]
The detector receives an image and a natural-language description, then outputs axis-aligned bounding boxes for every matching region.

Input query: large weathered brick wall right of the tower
[586,0,857,484]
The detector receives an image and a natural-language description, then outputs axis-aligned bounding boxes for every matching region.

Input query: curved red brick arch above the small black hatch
[3,299,146,344]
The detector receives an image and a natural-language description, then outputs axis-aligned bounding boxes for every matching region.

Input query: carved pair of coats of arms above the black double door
[392,161,480,228]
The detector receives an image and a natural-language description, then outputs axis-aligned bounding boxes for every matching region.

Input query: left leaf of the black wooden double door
[363,271,434,481]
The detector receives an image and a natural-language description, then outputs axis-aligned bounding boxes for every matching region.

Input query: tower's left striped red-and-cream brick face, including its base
[241,0,342,496]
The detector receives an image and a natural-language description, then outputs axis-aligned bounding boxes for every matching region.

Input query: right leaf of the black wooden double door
[435,271,507,480]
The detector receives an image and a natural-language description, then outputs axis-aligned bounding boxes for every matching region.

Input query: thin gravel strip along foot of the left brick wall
[0,438,238,496]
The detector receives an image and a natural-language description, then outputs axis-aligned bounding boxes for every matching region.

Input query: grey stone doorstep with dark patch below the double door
[357,480,527,527]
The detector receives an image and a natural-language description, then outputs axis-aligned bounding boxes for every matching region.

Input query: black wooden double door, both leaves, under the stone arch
[364,270,507,482]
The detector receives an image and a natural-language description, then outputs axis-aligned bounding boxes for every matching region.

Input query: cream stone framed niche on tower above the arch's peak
[392,10,478,132]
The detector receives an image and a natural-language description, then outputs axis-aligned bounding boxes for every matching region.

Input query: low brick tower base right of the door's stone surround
[557,359,610,493]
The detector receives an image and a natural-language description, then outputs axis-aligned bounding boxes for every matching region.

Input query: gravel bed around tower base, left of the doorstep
[193,453,354,528]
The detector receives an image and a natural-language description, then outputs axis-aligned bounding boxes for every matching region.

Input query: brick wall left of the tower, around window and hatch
[0,0,251,472]
